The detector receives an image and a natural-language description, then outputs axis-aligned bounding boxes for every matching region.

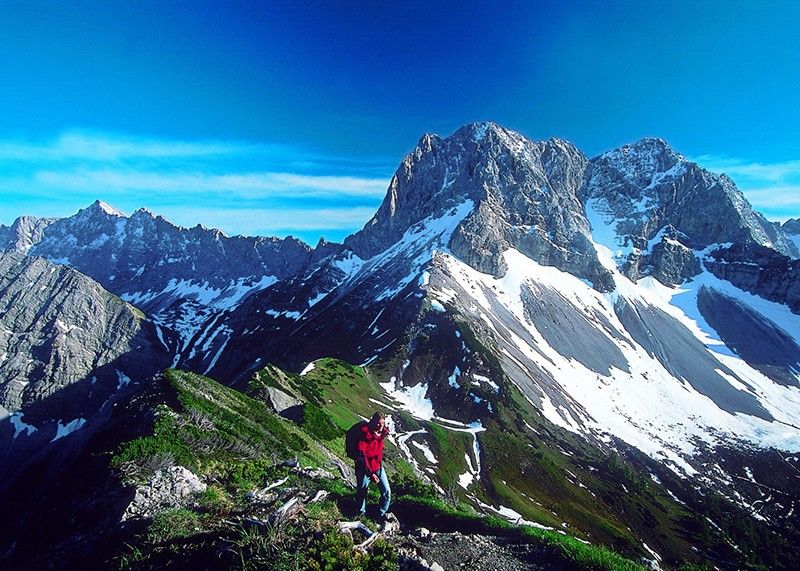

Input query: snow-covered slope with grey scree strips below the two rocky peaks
[429,250,800,474]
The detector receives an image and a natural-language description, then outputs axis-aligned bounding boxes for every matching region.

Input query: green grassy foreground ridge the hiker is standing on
[112,359,640,570]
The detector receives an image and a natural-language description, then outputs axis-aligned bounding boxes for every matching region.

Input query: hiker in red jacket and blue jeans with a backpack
[353,412,392,520]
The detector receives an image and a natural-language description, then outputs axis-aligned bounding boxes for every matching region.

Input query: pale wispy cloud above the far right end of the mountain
[691,155,800,221]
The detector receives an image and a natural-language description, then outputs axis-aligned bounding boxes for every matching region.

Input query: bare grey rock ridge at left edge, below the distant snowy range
[0,253,168,422]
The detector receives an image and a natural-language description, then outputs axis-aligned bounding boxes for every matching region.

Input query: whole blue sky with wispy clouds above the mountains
[0,0,800,243]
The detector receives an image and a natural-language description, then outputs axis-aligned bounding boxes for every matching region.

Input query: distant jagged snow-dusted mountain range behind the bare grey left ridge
[0,201,324,362]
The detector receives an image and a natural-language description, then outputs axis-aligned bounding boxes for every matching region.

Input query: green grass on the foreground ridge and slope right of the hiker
[112,359,664,570]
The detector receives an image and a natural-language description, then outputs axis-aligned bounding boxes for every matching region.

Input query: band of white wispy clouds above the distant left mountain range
[0,131,394,239]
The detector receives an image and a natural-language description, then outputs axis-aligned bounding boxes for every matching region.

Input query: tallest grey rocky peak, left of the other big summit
[345,123,609,289]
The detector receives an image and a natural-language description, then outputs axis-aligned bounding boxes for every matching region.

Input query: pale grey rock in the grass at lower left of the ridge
[122,466,207,521]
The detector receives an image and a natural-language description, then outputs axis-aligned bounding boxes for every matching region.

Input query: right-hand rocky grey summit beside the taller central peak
[580,138,797,284]
